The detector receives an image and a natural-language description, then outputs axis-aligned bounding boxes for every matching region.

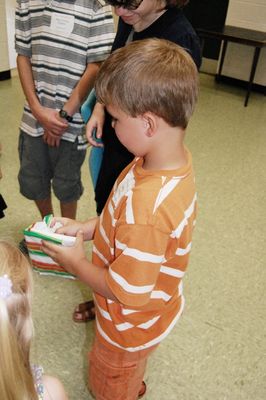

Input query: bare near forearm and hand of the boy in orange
[42,231,118,302]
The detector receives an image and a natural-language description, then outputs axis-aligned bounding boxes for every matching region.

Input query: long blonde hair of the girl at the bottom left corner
[0,240,38,400]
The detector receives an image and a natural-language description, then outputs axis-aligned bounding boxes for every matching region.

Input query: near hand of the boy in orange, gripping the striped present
[41,231,86,275]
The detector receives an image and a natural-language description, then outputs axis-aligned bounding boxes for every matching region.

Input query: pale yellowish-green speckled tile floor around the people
[0,75,266,400]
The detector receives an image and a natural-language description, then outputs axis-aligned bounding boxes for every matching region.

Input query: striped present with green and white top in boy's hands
[23,215,76,279]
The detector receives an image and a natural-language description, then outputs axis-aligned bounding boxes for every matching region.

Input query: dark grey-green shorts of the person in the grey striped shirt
[18,132,86,203]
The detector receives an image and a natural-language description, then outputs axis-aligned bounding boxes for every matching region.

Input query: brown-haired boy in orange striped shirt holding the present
[43,39,198,400]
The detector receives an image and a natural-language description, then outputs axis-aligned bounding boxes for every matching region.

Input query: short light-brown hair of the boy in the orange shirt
[95,39,198,129]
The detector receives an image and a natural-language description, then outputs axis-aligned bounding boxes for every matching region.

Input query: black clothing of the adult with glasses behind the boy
[95,8,201,214]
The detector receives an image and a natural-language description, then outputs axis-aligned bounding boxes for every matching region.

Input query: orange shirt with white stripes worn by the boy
[92,151,197,352]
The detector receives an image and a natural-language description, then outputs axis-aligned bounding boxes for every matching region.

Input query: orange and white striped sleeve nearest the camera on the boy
[106,225,168,307]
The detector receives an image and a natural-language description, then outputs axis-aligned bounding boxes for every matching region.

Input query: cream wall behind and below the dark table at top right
[222,0,266,85]
